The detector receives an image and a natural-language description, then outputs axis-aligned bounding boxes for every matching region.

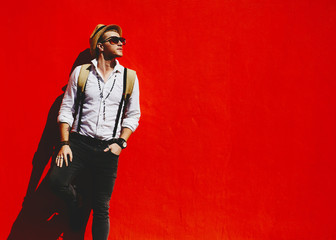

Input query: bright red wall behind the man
[0,0,336,240]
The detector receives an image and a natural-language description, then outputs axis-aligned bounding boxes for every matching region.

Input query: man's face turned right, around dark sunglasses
[97,31,123,60]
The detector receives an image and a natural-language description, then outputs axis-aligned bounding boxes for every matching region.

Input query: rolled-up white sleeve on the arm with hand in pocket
[121,76,141,132]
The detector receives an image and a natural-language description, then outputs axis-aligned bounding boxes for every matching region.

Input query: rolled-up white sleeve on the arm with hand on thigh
[57,67,80,127]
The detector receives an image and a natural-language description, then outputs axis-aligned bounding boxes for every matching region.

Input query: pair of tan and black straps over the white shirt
[75,64,136,138]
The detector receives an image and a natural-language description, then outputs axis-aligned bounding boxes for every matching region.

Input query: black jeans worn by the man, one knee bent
[49,134,119,240]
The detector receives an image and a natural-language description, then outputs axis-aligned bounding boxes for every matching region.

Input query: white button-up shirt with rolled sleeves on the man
[58,59,140,140]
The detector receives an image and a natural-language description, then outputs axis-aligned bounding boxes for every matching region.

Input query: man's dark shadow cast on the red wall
[7,49,91,240]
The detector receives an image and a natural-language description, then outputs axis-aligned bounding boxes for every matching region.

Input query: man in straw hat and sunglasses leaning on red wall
[50,24,140,240]
